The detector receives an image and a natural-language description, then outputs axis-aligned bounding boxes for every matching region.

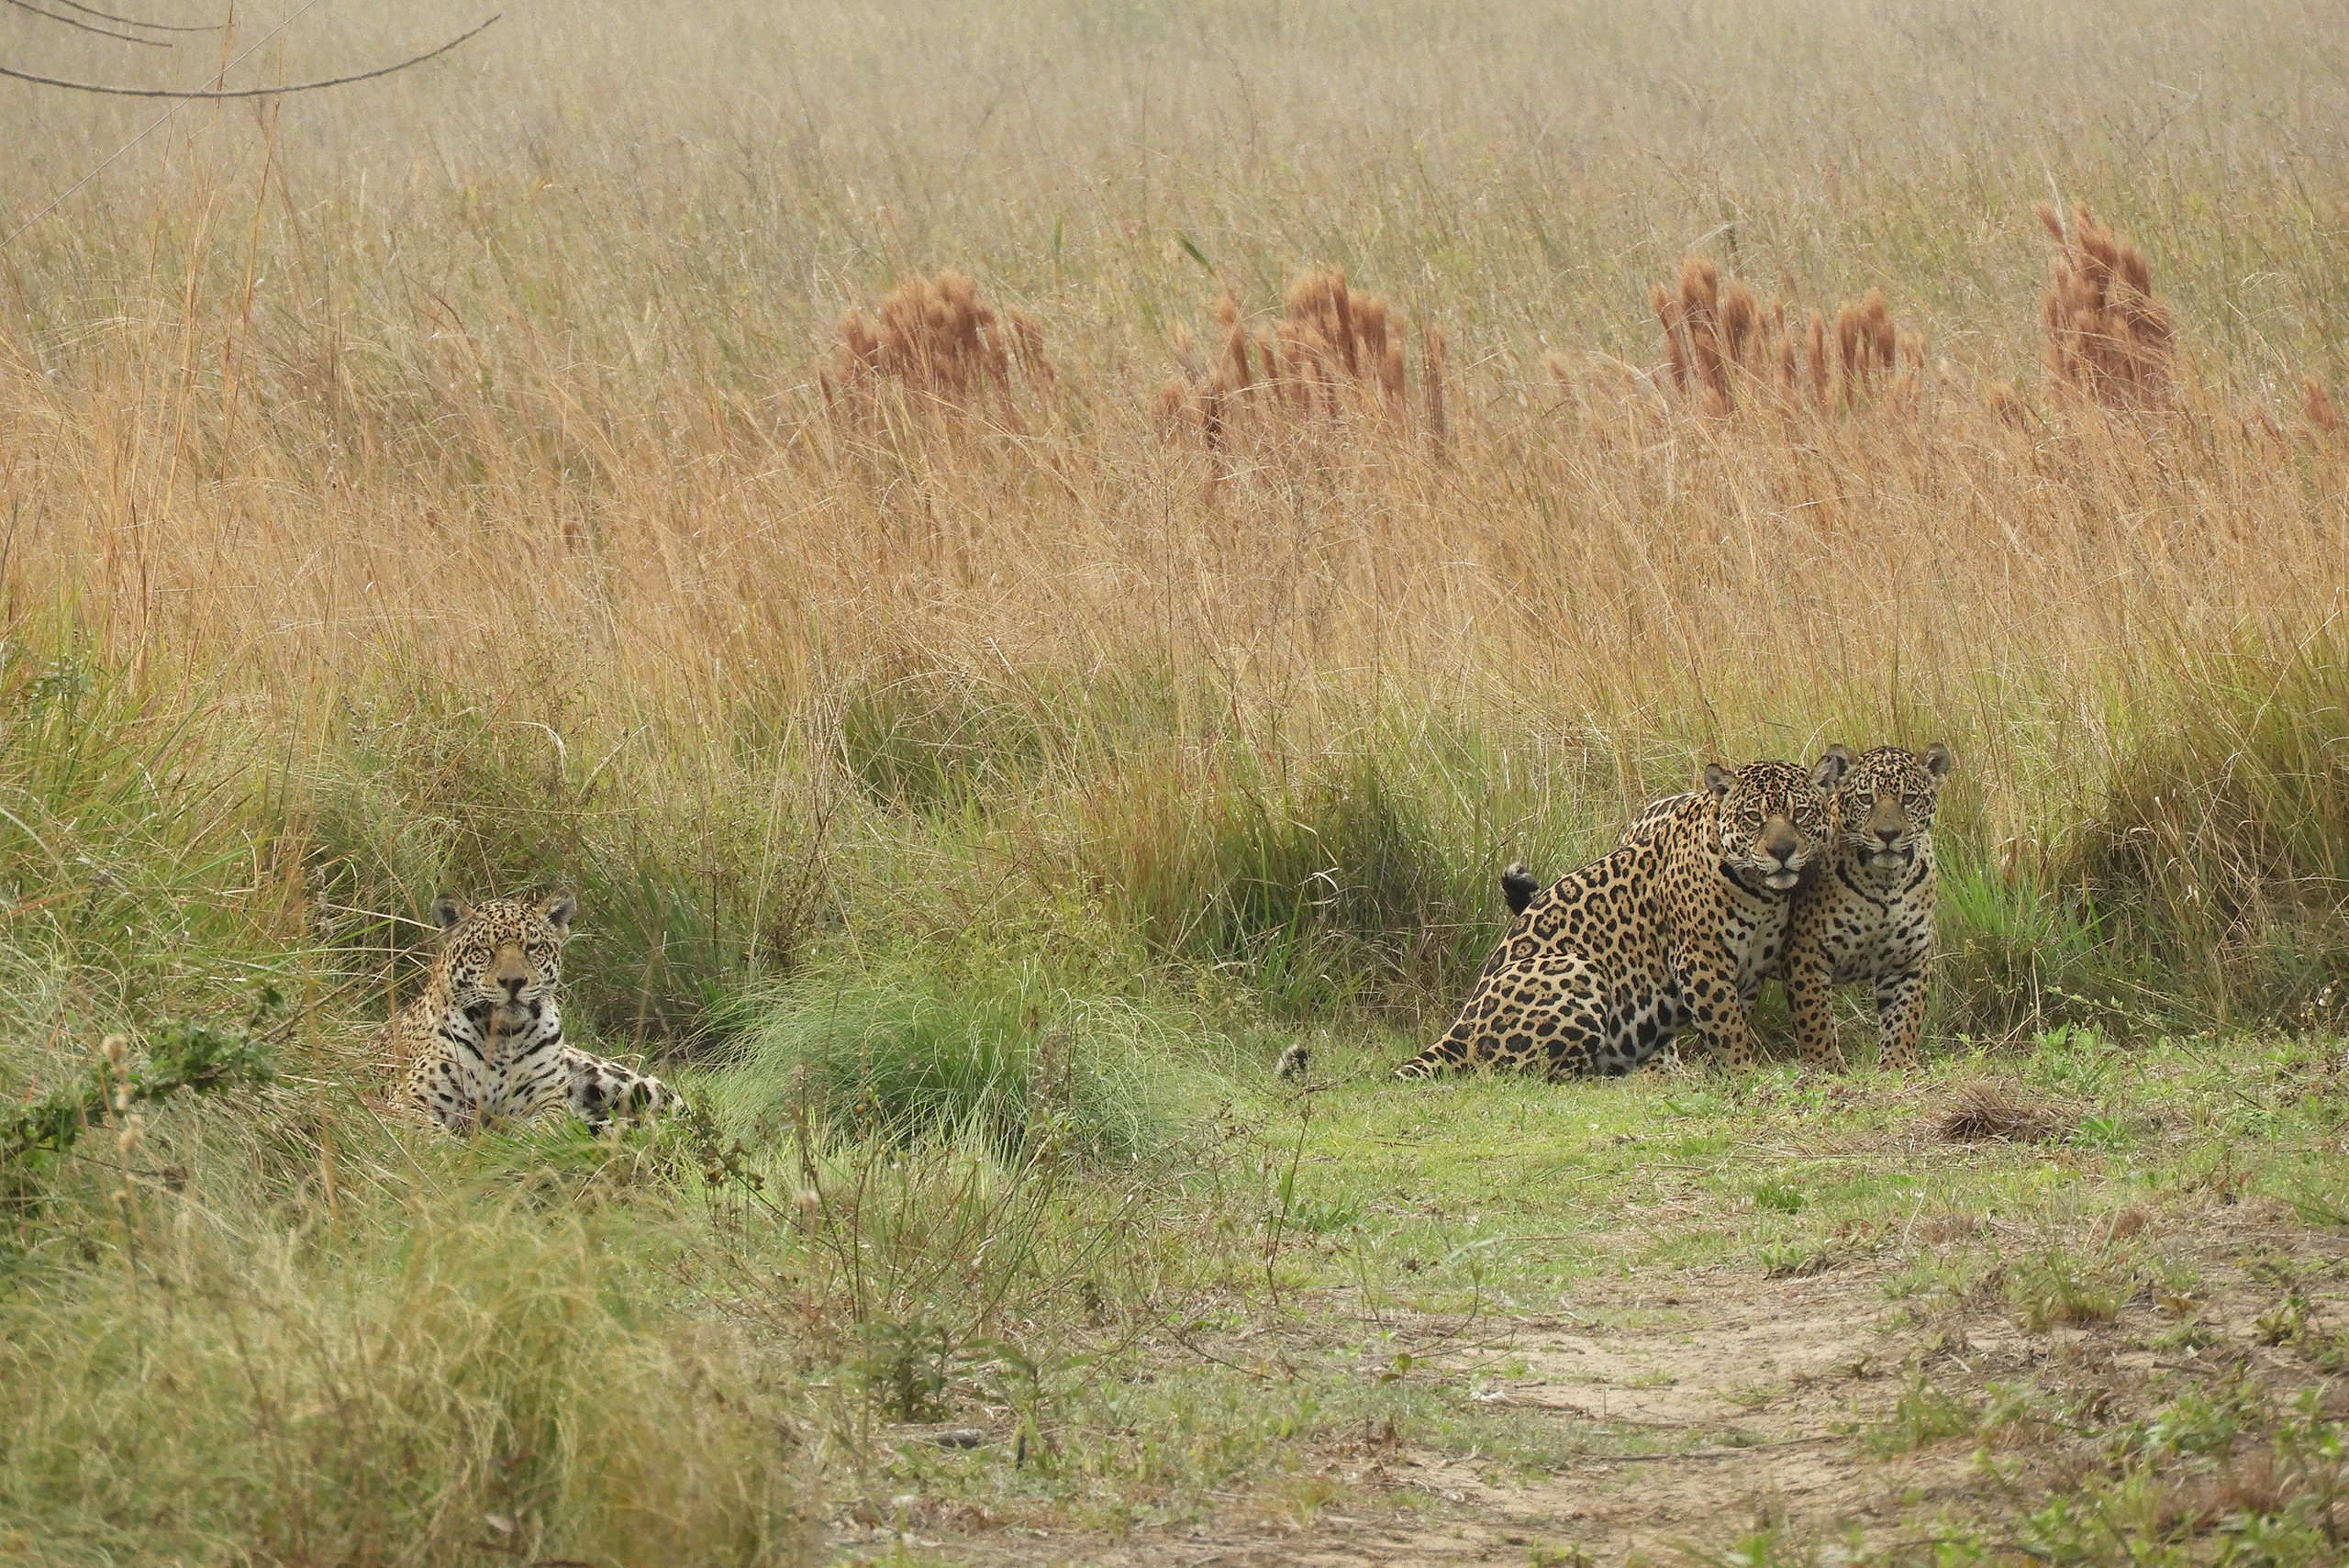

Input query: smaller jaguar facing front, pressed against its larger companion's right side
[1786,741,1954,1073]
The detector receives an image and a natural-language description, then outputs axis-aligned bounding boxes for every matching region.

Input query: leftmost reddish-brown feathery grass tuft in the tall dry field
[822,270,1052,423]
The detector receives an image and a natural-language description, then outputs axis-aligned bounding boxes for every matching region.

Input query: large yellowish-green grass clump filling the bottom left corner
[0,1159,808,1565]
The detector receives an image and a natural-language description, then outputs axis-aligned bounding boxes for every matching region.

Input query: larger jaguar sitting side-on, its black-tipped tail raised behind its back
[1396,756,1844,1077]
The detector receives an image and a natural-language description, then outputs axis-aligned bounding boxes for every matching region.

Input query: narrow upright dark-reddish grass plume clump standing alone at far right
[2039,202,2176,408]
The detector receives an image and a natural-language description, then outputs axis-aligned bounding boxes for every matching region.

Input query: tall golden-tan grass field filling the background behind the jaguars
[0,3,2349,1038]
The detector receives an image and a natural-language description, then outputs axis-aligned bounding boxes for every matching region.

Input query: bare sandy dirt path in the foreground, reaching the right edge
[839,1192,2349,1568]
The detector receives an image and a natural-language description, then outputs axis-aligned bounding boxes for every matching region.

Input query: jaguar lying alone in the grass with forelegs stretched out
[383,895,679,1134]
